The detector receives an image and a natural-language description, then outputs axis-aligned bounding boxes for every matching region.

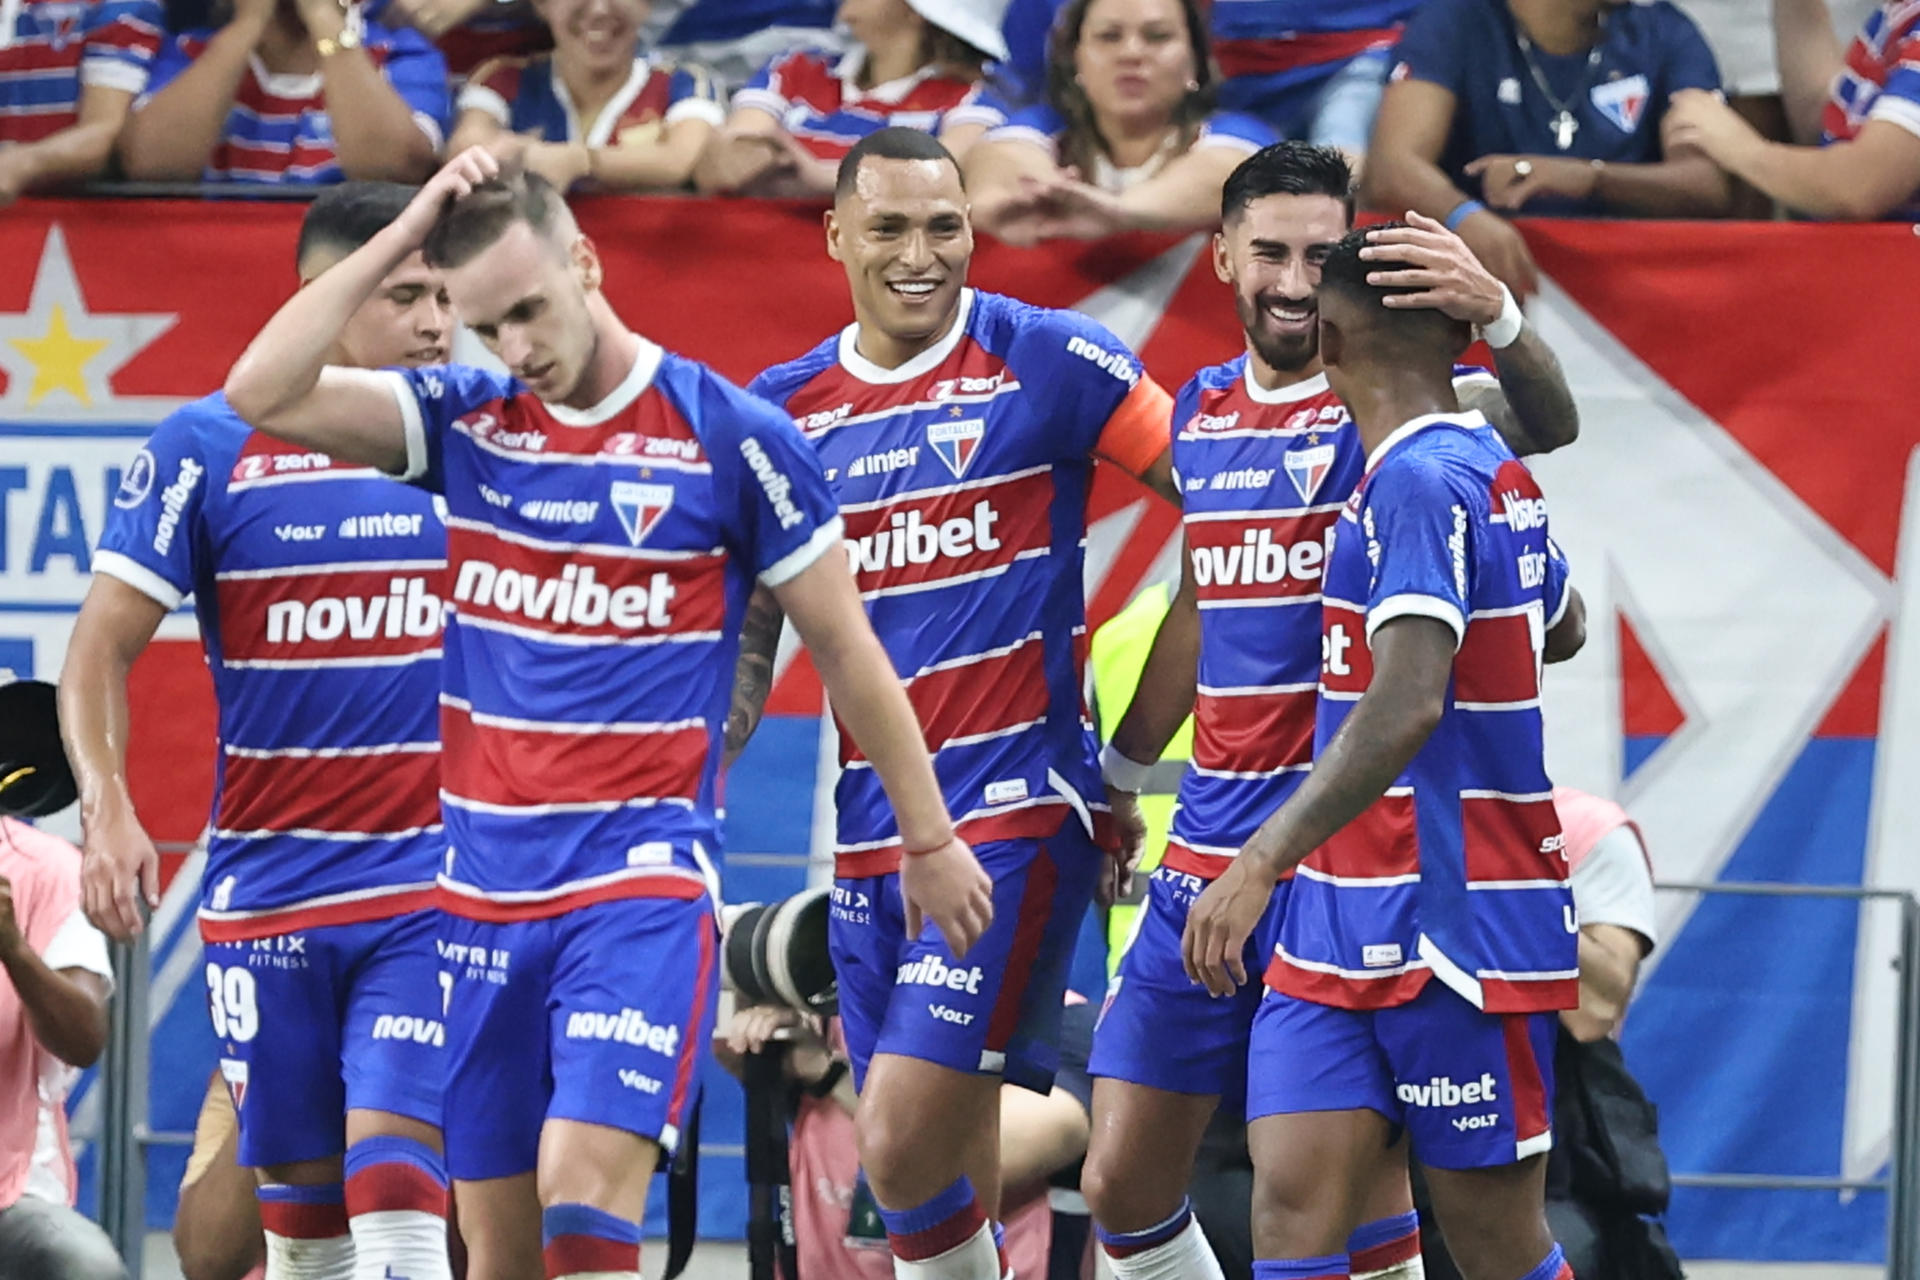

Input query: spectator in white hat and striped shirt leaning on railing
[695,0,1006,200]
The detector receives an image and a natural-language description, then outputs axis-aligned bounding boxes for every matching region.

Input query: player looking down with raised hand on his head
[214,148,991,1280]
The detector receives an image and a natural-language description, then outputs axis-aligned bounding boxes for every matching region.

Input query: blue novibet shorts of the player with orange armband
[828,819,1106,1092]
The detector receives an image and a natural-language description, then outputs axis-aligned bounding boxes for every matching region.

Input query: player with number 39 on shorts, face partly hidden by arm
[60,182,451,1280]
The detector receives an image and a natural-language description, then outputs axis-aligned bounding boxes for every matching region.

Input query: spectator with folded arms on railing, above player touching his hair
[447,0,726,192]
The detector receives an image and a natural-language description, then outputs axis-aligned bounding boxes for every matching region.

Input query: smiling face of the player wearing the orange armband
[828,155,973,362]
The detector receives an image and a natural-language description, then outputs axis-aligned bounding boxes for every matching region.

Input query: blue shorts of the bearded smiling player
[1087,865,1292,1111]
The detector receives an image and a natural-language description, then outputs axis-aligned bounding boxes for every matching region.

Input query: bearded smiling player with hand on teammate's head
[1081,142,1578,1280]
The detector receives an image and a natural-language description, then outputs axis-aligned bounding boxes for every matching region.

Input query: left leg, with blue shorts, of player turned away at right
[1246,992,1398,1280]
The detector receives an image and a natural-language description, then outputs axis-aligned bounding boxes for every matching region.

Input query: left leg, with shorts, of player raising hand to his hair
[436,915,553,1280]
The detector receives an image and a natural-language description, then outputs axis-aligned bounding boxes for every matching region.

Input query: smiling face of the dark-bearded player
[1213,196,1346,372]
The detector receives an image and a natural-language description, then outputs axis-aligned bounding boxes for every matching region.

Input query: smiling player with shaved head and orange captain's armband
[735,129,1173,1280]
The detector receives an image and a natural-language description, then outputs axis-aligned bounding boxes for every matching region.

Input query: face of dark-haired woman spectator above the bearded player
[1073,0,1196,121]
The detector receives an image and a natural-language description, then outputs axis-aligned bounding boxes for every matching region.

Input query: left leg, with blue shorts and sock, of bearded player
[1081,865,1265,1280]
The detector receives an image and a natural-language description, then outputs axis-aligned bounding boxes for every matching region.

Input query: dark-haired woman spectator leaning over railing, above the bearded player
[966,0,1275,244]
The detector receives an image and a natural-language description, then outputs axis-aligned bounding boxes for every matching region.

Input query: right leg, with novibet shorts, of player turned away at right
[1380,983,1572,1280]
